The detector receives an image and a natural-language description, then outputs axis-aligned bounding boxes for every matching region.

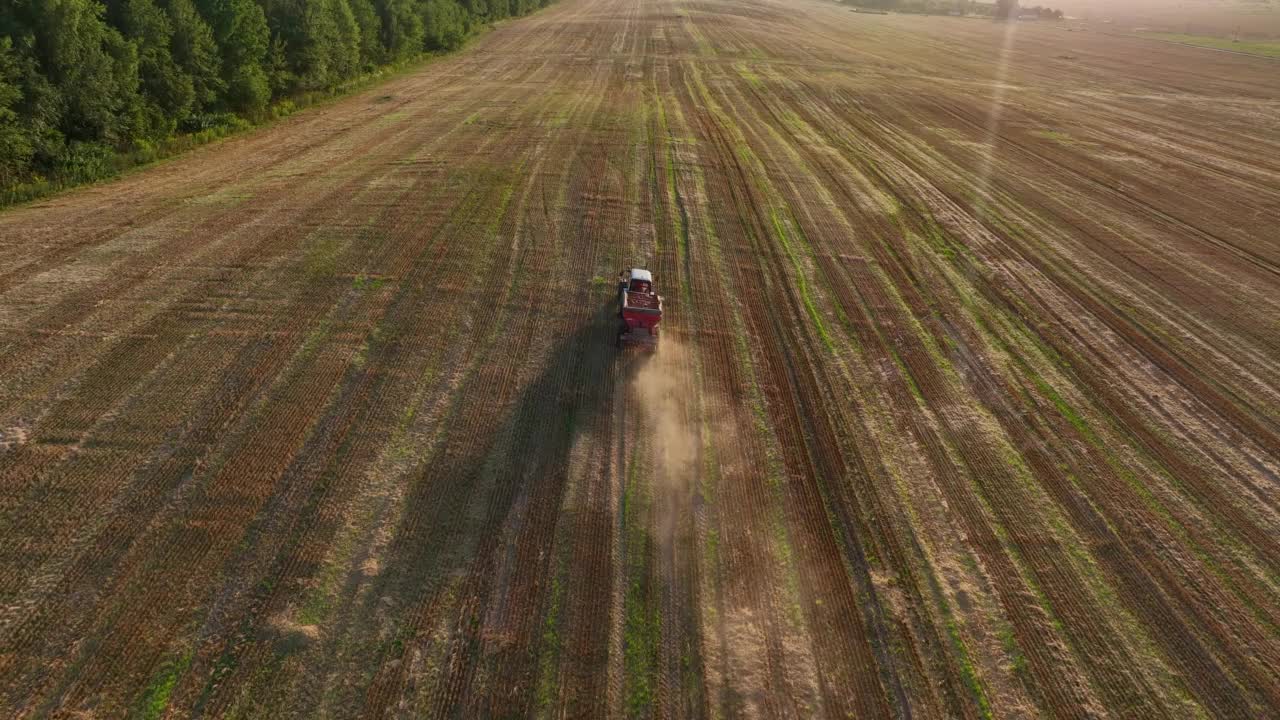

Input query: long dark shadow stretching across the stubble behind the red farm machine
[337,295,646,714]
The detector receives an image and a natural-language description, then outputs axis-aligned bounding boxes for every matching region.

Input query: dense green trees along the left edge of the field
[0,0,549,194]
